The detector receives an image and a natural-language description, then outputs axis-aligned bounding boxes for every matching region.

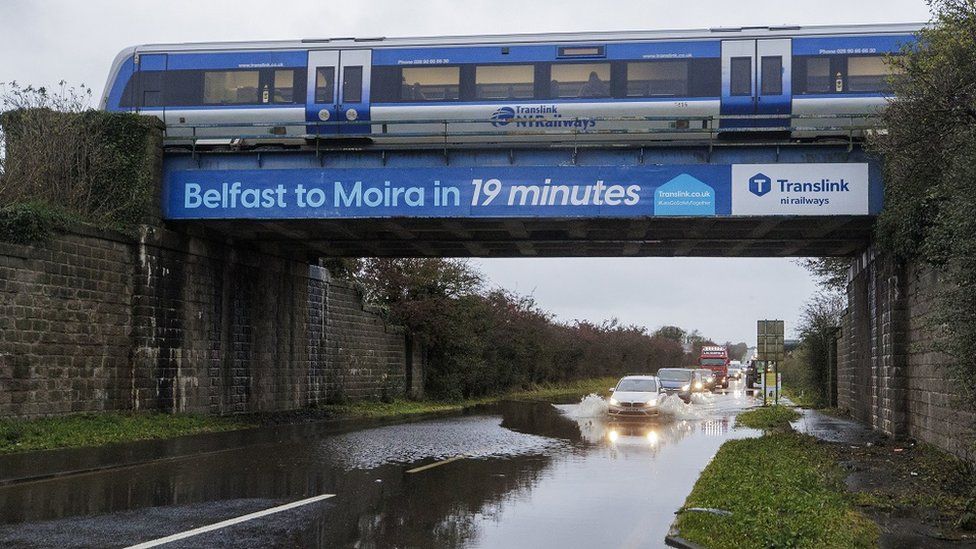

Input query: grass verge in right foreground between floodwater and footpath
[676,432,878,549]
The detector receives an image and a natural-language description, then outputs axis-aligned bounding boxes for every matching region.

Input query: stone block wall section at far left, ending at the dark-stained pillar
[0,227,133,417]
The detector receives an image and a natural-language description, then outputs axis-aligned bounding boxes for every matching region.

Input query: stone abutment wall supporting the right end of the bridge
[837,250,976,459]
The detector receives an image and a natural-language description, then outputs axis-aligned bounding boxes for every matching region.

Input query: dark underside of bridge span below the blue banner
[181,216,874,257]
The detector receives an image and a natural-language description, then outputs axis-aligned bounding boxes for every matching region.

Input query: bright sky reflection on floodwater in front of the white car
[465,393,755,547]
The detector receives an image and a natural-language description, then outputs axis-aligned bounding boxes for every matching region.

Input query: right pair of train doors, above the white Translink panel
[721,38,793,128]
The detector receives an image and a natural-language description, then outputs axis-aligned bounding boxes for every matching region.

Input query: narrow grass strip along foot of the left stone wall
[0,413,254,454]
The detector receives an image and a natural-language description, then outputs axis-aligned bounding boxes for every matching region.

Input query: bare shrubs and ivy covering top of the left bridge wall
[0,83,162,243]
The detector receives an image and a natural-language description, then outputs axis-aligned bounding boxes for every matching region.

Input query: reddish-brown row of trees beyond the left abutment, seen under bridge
[340,258,684,399]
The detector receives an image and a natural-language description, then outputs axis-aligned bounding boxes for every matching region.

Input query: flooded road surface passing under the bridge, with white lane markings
[0,384,755,548]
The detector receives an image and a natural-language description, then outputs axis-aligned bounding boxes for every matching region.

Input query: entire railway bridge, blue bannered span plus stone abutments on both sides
[0,109,957,456]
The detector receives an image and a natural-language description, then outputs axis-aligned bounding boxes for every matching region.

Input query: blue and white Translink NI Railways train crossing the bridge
[101,24,921,144]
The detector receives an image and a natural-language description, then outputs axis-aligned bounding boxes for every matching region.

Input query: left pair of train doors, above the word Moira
[305,50,372,136]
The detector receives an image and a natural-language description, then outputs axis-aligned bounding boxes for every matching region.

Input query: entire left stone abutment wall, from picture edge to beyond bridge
[0,223,423,417]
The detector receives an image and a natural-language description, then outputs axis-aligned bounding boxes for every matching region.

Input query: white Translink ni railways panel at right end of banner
[732,163,870,215]
